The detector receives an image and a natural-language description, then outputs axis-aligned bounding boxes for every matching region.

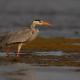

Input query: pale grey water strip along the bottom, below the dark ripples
[0,63,80,80]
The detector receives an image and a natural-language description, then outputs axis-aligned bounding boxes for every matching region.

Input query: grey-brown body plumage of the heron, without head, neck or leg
[0,28,39,46]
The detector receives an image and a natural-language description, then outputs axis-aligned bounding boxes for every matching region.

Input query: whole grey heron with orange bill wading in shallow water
[0,20,51,56]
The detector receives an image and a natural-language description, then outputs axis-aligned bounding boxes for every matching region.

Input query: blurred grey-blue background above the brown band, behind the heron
[0,0,80,37]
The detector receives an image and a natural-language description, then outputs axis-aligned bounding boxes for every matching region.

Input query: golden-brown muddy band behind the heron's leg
[1,37,80,53]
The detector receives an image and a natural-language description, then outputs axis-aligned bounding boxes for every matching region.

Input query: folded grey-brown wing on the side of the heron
[7,29,32,44]
